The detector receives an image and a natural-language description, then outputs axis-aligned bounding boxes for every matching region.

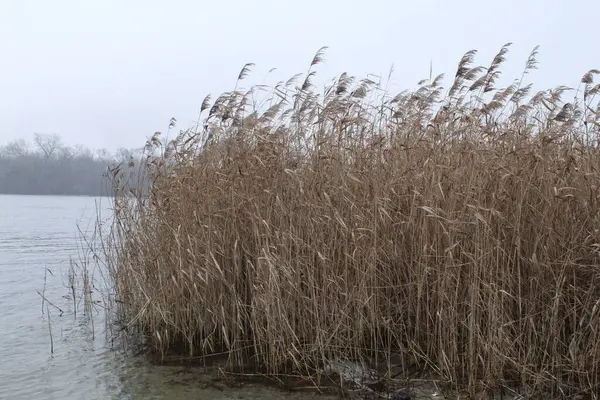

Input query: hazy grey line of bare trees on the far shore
[0,134,140,196]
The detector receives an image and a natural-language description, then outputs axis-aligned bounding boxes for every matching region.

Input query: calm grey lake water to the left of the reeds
[0,195,332,400]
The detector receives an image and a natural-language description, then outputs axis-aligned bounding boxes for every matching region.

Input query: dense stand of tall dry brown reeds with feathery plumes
[98,45,600,394]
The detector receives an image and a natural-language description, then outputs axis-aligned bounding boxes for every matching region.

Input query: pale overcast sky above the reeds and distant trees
[0,0,600,150]
